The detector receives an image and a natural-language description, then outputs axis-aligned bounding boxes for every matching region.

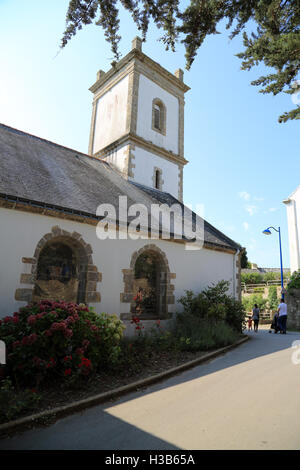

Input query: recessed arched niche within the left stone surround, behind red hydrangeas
[33,241,83,302]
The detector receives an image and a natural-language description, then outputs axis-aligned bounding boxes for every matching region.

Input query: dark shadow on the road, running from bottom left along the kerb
[0,330,300,450]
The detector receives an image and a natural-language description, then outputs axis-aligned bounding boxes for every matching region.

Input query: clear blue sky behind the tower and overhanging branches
[0,0,300,267]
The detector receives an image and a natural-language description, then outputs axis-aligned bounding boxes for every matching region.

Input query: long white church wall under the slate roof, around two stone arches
[0,209,235,326]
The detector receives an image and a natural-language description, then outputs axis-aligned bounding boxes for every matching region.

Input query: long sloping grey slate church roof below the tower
[0,124,241,250]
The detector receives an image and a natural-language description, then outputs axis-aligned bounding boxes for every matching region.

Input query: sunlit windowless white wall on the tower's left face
[93,75,129,153]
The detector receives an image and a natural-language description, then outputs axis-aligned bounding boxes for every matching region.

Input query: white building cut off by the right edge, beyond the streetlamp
[283,186,300,273]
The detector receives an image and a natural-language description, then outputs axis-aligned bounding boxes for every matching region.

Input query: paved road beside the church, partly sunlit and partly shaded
[0,330,300,450]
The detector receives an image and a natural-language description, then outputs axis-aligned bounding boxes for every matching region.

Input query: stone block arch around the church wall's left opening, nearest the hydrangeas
[15,226,102,304]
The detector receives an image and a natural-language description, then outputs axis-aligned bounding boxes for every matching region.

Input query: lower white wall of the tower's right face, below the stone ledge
[130,145,179,199]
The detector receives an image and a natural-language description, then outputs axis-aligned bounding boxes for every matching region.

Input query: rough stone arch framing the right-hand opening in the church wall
[120,244,176,320]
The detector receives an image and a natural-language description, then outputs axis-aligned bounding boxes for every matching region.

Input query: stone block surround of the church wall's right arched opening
[120,244,176,320]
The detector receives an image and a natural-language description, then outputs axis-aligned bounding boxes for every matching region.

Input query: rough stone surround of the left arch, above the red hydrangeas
[15,225,102,305]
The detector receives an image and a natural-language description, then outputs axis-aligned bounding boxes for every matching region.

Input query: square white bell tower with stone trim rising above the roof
[89,37,189,201]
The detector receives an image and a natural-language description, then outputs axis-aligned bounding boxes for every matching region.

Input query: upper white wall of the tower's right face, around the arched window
[137,74,179,154]
